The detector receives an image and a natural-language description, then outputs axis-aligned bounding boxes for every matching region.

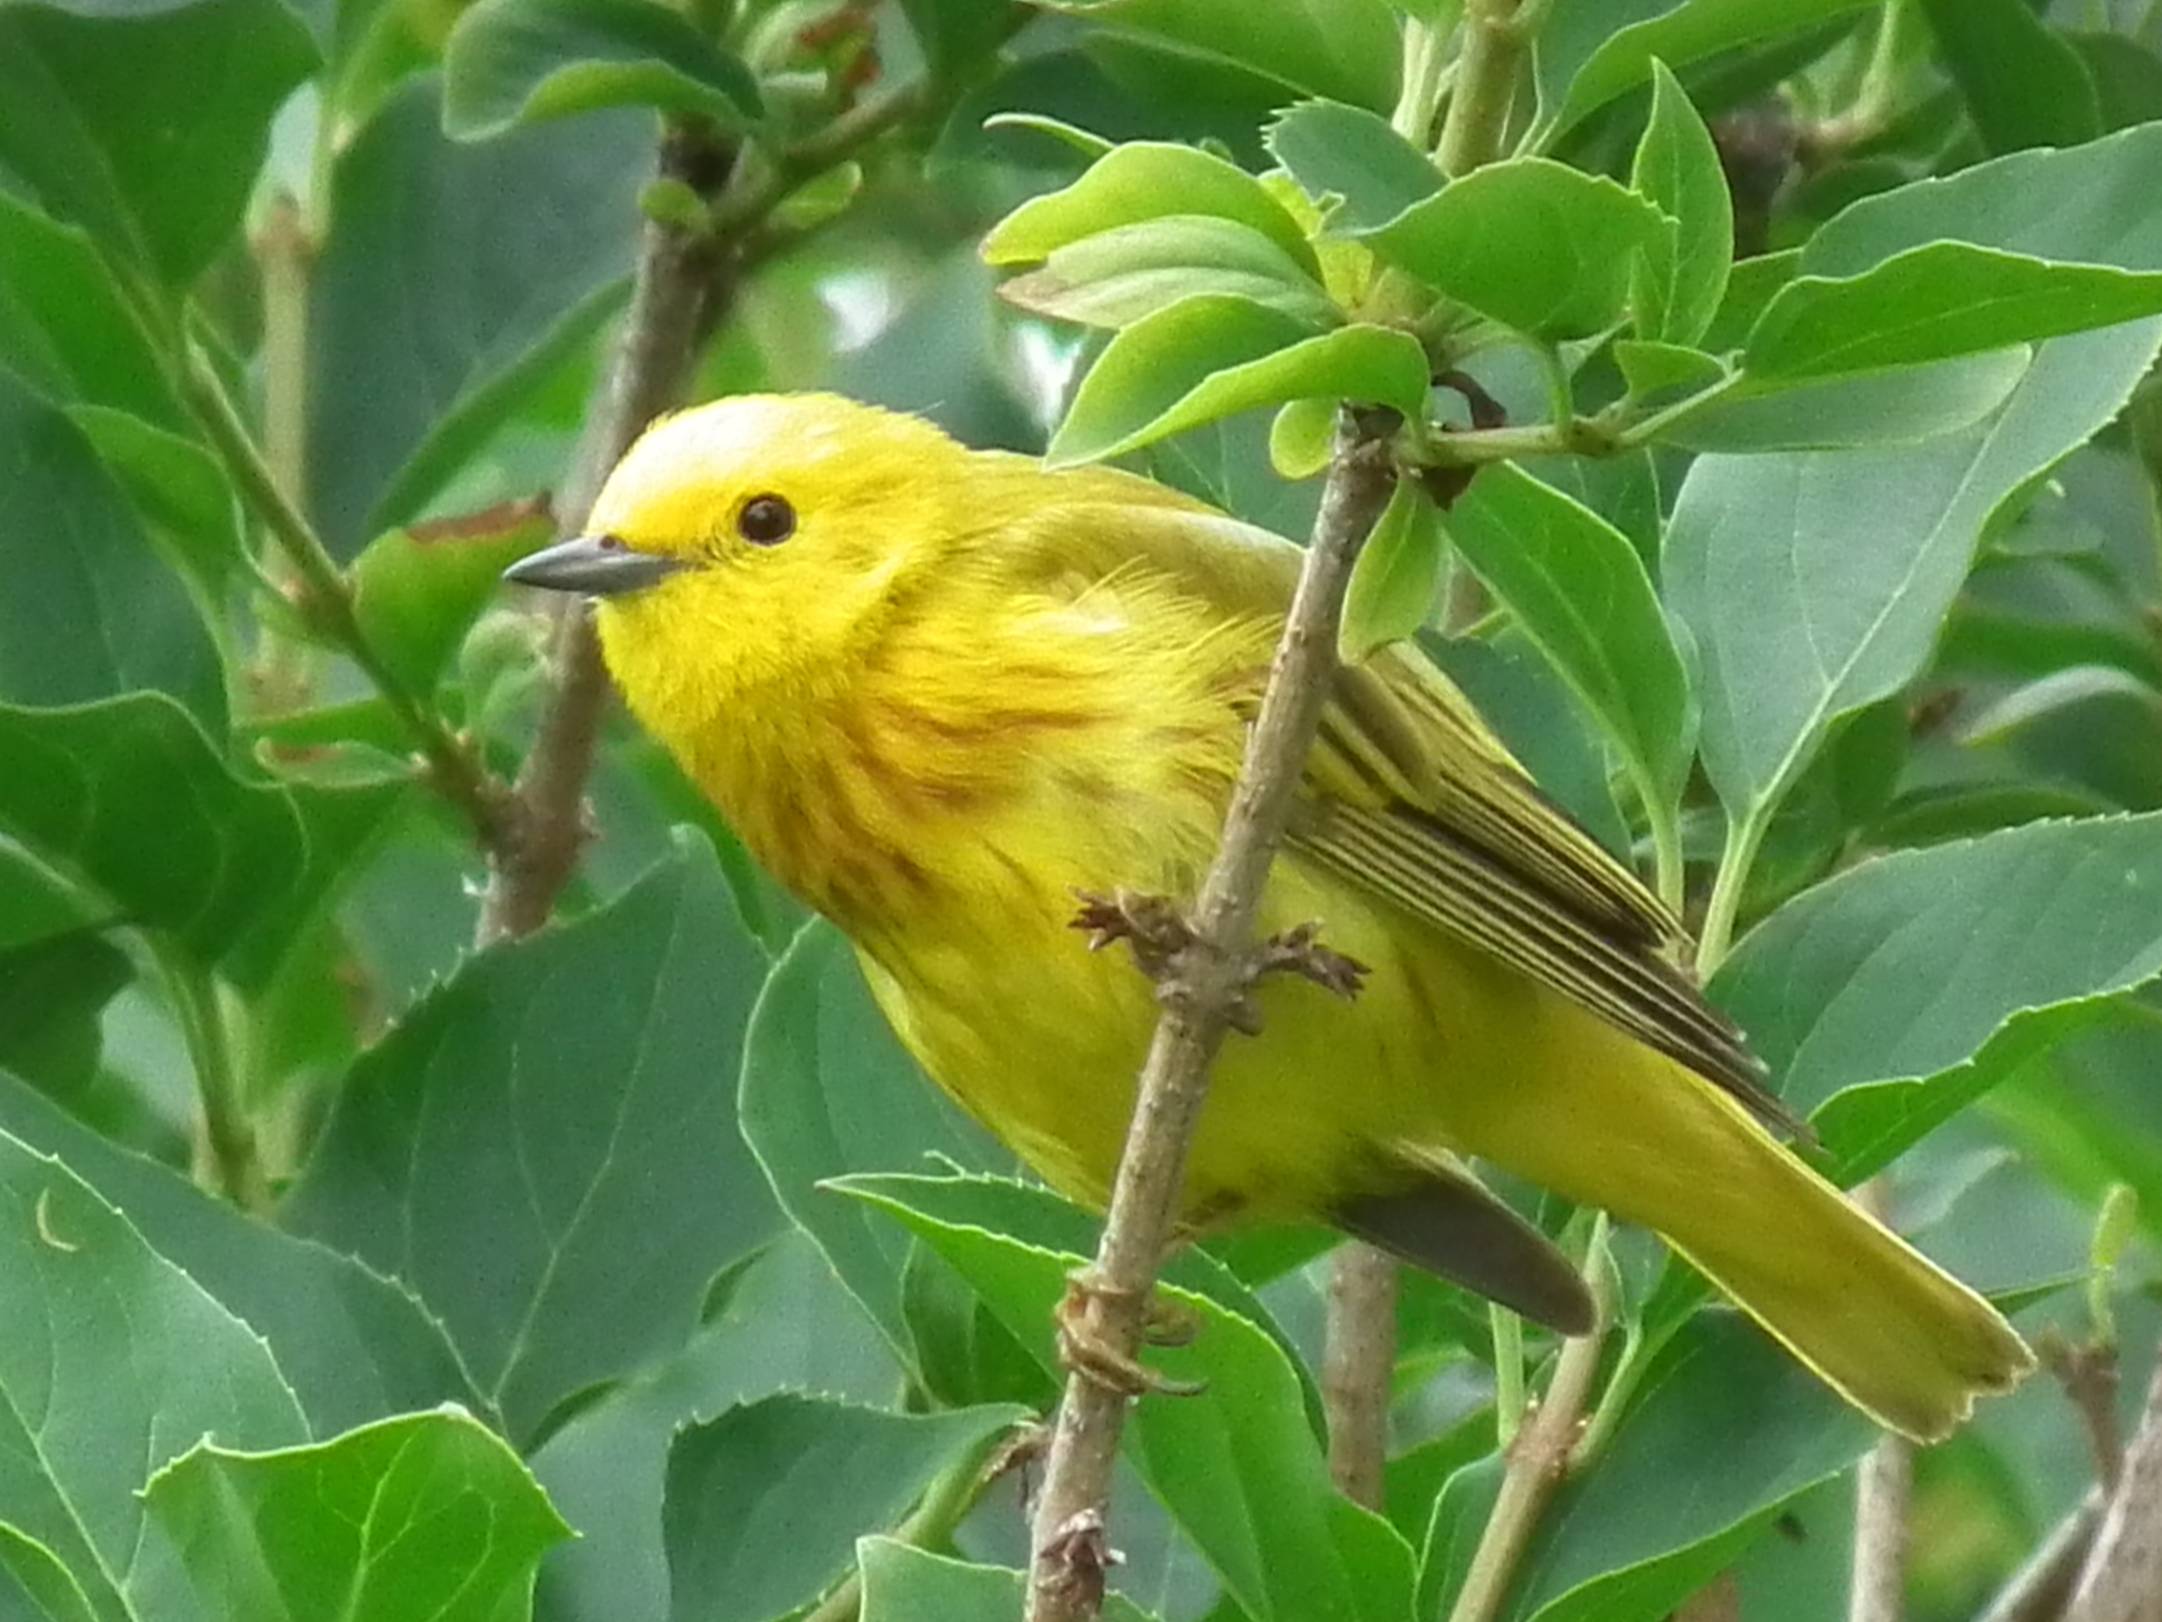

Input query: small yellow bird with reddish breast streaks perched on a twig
[508,394,2032,1438]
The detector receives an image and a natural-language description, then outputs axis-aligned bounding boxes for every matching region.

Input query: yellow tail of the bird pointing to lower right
[1470,1049,2034,1440]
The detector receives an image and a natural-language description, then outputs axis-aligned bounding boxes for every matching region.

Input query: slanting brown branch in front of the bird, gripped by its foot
[1029,411,1394,1622]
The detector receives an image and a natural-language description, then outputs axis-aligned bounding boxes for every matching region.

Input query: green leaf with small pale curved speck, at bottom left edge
[0,1133,307,1620]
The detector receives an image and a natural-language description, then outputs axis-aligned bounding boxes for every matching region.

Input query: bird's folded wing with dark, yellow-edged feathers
[1062,499,1805,1131]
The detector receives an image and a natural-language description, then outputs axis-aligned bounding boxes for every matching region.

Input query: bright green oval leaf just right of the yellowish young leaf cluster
[1360,158,1667,340]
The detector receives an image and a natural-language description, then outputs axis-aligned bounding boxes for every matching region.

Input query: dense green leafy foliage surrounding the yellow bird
[0,0,2162,1622]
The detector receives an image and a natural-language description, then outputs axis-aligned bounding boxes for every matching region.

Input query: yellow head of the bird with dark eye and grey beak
[506,394,973,742]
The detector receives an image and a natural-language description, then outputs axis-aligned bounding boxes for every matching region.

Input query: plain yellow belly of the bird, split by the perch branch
[863,854,1617,1226]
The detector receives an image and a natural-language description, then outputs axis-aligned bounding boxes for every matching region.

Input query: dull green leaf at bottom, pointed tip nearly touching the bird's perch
[666,1393,1033,1622]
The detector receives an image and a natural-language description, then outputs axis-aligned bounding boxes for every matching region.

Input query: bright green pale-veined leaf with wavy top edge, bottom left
[143,1408,571,1622]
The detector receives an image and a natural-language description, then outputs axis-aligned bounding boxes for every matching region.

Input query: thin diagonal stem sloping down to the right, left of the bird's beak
[177,342,502,843]
